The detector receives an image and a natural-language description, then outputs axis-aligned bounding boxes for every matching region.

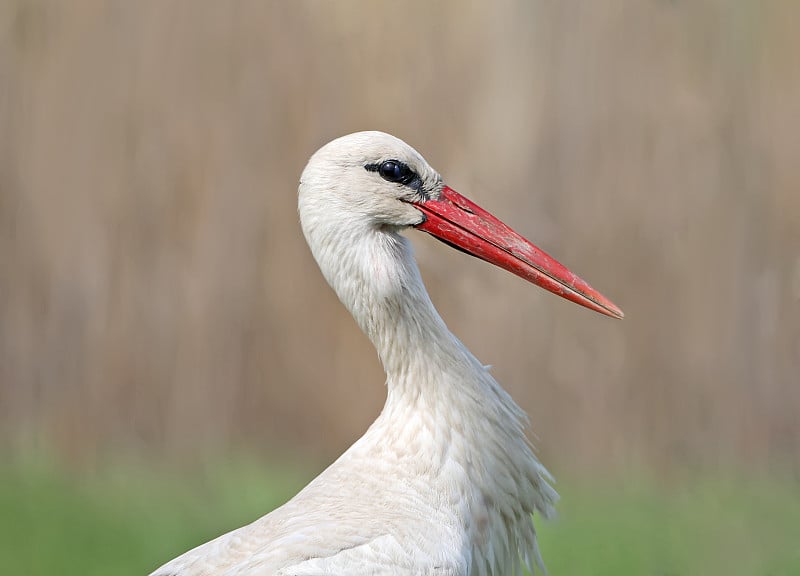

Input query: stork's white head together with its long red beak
[299,132,623,318]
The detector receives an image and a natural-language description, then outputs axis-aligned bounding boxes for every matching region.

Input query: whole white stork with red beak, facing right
[153,132,623,576]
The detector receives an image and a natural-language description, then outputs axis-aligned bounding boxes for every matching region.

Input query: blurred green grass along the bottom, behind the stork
[0,459,800,576]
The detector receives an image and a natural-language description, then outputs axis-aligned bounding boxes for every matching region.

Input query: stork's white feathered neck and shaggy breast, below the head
[309,224,557,574]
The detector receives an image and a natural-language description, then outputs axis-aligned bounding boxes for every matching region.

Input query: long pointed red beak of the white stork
[415,186,624,318]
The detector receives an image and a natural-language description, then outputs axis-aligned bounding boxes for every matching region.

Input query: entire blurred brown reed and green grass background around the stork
[0,0,800,575]
